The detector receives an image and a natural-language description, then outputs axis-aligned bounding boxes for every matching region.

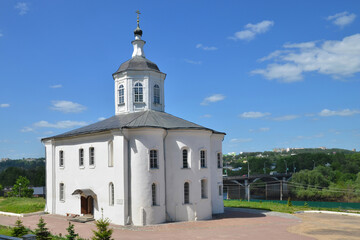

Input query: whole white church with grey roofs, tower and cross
[42,15,225,225]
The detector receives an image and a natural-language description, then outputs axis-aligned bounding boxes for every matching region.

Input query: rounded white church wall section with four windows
[166,130,212,221]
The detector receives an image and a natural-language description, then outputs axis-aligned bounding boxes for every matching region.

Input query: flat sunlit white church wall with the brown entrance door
[45,134,125,224]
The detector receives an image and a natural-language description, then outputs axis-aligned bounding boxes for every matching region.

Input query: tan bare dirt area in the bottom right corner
[288,213,360,240]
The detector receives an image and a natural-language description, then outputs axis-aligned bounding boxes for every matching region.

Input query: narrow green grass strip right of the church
[224,200,358,213]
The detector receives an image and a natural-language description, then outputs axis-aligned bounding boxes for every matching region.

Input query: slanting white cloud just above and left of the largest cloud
[230,20,274,41]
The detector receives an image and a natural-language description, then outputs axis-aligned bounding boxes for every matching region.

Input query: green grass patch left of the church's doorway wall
[0,197,45,213]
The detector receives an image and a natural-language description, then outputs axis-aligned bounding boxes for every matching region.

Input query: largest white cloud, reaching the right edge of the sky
[251,34,360,83]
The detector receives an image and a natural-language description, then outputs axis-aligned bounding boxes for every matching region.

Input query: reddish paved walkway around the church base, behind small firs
[0,209,314,240]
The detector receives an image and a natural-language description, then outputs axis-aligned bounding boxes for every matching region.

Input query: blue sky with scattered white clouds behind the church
[0,0,360,158]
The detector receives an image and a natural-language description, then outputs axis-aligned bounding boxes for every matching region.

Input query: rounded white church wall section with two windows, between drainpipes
[129,129,166,225]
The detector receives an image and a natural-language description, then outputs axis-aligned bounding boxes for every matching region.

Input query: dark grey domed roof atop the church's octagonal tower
[114,56,160,74]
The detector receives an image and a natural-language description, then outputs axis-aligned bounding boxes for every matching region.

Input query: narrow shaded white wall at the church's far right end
[211,134,224,214]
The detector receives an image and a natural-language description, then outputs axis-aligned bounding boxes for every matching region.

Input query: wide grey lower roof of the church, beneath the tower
[42,110,225,140]
